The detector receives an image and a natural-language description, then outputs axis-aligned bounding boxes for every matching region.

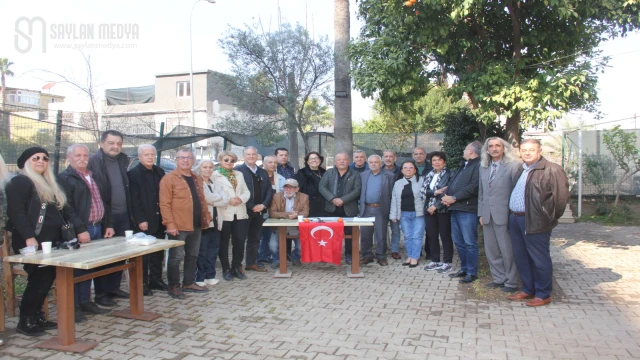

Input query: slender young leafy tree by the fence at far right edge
[603,125,640,210]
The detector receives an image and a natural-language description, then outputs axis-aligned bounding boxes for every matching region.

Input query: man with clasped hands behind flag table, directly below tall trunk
[319,152,362,264]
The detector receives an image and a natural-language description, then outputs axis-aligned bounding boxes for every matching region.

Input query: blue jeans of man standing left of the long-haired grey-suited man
[451,210,478,275]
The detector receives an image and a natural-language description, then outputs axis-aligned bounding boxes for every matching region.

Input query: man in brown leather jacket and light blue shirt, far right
[508,139,569,306]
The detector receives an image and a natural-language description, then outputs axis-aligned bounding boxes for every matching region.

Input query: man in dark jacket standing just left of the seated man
[234,146,273,272]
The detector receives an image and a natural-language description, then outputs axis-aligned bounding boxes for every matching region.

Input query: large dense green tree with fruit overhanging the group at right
[350,0,640,145]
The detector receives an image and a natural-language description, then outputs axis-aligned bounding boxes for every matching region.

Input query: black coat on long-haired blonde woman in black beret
[6,175,71,254]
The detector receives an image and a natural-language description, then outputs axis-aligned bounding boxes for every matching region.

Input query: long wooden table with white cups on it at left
[4,237,184,352]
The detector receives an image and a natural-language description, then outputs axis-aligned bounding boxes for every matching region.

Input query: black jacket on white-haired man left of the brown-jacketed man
[127,164,166,235]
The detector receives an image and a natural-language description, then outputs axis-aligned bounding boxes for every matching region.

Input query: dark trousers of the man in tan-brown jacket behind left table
[167,229,202,286]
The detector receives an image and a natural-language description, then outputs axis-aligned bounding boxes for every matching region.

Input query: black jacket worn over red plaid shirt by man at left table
[58,166,113,234]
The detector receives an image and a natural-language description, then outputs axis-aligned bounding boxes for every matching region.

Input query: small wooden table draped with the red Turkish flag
[262,218,373,278]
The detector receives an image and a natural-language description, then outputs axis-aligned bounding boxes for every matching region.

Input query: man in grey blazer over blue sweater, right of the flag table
[359,155,395,266]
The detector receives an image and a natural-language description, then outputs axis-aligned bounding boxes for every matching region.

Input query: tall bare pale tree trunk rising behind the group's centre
[333,0,353,156]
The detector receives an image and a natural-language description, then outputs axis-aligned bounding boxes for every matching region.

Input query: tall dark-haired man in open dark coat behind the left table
[87,130,133,307]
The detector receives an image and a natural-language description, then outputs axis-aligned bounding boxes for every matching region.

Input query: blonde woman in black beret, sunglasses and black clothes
[6,147,74,336]
